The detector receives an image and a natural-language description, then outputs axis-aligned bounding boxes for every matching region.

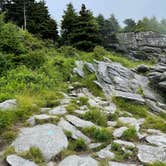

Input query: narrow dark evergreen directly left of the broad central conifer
[61,3,78,45]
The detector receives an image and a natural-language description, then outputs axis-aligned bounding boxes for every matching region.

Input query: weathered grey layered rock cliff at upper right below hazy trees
[117,32,166,59]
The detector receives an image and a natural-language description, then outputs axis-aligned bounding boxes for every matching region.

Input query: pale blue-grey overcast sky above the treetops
[45,0,166,25]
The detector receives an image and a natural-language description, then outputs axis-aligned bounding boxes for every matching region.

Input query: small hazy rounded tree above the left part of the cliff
[123,18,136,32]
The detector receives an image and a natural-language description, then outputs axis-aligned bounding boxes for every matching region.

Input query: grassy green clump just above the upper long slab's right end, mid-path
[83,108,107,126]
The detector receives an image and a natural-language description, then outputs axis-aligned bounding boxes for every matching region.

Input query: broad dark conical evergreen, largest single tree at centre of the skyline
[71,4,101,51]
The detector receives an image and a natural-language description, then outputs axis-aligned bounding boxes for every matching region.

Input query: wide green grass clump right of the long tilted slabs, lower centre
[83,127,112,142]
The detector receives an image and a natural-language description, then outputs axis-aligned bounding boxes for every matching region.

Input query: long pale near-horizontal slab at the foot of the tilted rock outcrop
[114,91,145,104]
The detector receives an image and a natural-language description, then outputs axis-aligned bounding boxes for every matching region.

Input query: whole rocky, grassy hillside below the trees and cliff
[0,15,166,166]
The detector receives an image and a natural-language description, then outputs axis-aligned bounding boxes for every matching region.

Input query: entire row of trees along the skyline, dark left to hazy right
[0,0,166,51]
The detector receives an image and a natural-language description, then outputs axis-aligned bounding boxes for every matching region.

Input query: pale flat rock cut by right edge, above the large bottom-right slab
[146,134,166,147]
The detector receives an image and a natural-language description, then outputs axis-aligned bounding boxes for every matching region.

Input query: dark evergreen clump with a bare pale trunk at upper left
[5,0,58,40]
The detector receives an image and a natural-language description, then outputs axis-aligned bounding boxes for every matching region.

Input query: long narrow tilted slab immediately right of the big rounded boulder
[58,118,91,143]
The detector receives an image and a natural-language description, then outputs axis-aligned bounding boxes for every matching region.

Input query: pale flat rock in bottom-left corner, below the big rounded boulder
[6,155,37,166]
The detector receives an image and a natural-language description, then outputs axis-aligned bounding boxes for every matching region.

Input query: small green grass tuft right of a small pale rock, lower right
[122,127,138,141]
